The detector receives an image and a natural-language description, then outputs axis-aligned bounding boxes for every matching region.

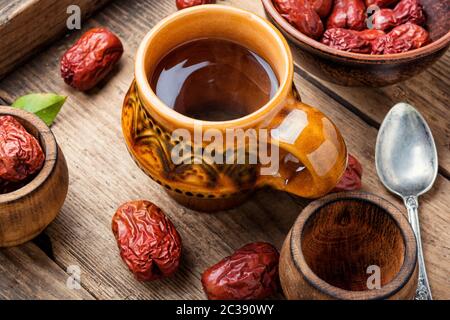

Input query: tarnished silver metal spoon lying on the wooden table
[375,103,438,300]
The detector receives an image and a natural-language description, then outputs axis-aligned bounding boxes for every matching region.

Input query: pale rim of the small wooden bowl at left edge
[0,106,58,204]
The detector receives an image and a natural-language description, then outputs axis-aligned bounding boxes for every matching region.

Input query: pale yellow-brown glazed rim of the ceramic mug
[135,4,294,129]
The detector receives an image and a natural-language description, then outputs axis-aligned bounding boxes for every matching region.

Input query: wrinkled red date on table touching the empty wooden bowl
[202,242,279,300]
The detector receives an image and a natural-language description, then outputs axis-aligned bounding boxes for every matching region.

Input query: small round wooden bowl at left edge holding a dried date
[0,106,69,247]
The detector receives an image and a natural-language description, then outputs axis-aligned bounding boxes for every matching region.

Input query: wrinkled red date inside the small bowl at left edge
[0,116,45,182]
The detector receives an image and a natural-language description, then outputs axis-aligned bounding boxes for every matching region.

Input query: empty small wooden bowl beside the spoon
[280,193,417,300]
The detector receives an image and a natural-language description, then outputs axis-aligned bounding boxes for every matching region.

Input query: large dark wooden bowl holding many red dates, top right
[262,0,450,87]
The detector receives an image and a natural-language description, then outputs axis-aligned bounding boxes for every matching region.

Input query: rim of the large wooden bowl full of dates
[261,0,450,63]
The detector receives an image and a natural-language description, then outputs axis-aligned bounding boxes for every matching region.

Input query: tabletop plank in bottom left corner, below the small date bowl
[0,243,93,300]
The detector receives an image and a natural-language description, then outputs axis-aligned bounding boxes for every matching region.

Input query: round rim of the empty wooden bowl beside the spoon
[289,192,417,300]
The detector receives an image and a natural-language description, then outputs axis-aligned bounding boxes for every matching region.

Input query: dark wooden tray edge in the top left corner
[0,0,108,78]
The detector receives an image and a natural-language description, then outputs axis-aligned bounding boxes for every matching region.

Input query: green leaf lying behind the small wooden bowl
[12,93,67,126]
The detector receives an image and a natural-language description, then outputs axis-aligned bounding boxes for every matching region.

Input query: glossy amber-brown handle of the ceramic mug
[259,89,347,198]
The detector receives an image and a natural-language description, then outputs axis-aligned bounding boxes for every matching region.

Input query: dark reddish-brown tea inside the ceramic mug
[149,39,279,121]
